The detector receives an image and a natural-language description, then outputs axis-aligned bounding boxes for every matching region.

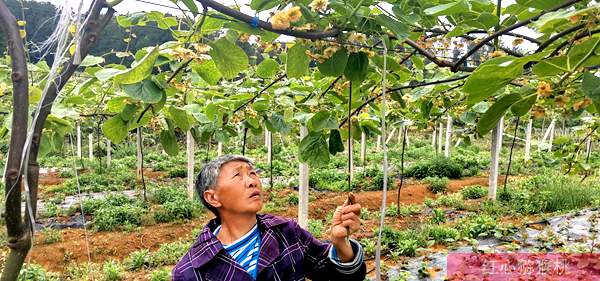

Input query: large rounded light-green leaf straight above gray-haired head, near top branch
[208,37,249,79]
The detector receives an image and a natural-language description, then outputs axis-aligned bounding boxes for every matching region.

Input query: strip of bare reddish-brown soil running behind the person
[31,177,487,272]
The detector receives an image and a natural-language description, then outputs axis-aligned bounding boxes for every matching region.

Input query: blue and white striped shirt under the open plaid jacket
[213,224,260,280]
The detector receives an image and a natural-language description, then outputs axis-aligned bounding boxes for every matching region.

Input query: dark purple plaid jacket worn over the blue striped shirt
[173,214,366,281]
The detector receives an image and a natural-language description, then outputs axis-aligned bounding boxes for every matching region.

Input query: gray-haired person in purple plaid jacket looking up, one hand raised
[173,155,366,281]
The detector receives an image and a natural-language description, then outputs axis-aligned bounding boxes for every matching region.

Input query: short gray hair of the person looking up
[196,154,254,217]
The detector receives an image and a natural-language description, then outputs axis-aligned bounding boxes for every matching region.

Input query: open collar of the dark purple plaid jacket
[190,214,288,268]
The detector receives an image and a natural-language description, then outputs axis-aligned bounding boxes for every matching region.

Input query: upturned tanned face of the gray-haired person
[209,161,263,214]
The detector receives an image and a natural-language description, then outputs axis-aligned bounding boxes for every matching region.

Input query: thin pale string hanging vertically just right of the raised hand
[375,38,388,281]
